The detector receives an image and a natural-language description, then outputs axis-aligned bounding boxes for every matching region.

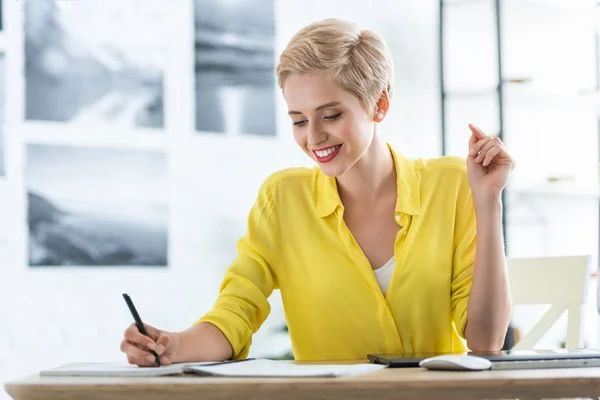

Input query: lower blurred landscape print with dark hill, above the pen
[26,144,168,267]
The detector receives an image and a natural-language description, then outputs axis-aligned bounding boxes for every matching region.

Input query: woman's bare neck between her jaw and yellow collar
[337,132,397,205]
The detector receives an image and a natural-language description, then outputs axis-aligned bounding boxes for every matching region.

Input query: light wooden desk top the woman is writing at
[5,368,600,400]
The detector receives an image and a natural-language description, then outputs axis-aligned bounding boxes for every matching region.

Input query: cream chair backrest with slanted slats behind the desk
[507,256,591,350]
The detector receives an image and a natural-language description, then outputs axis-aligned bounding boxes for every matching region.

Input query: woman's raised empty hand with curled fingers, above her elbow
[467,124,515,201]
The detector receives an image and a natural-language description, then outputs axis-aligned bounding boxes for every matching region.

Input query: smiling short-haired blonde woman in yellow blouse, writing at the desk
[121,19,514,366]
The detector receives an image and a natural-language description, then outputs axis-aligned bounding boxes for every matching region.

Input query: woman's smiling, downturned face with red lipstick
[283,73,376,177]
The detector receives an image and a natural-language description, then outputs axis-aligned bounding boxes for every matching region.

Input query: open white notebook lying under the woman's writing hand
[40,359,385,378]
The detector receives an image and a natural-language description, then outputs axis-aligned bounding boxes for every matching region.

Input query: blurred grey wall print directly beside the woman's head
[194,0,276,136]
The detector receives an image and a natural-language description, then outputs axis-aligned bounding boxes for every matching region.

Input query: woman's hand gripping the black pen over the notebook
[121,324,179,367]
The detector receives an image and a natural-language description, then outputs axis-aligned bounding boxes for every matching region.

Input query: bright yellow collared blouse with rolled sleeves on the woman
[196,146,476,360]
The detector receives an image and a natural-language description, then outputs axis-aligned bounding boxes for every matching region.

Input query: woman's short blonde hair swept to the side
[277,18,394,111]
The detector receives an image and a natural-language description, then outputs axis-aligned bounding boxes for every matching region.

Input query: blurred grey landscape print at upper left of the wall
[24,0,166,128]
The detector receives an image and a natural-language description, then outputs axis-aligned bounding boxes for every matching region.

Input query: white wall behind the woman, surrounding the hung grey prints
[0,0,439,397]
